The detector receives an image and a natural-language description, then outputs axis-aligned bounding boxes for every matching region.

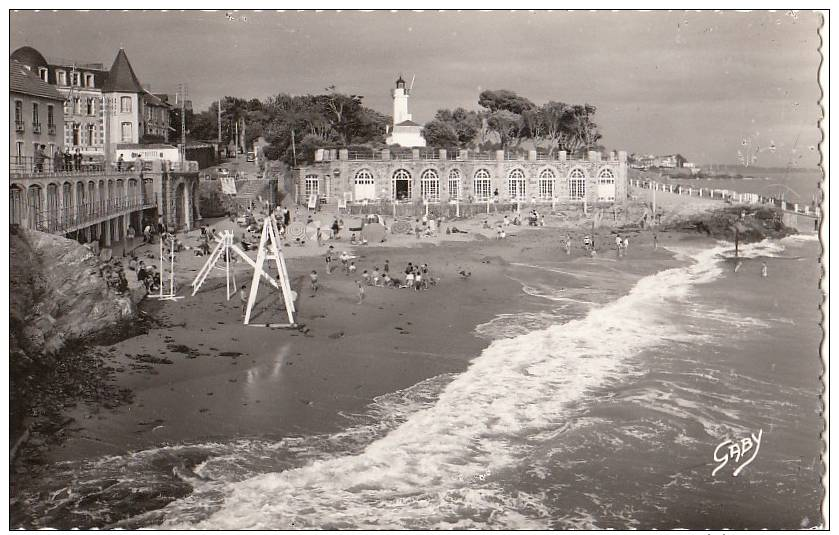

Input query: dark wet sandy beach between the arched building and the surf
[34,207,684,460]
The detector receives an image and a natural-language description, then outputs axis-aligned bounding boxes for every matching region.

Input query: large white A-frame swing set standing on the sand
[192,217,296,327]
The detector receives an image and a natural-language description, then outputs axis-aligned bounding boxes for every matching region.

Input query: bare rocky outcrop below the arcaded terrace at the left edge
[10,229,136,358]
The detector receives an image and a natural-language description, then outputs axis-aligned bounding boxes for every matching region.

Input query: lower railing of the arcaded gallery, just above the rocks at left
[27,195,158,234]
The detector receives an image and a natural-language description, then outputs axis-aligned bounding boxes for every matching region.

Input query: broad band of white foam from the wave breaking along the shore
[163,249,736,529]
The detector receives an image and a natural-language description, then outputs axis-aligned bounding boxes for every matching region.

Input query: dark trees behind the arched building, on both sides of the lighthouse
[184,86,602,165]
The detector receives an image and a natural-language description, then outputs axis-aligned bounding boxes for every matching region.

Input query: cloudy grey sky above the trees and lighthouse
[10,11,822,167]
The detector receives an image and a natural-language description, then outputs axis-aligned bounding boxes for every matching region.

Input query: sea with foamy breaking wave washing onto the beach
[12,235,824,529]
